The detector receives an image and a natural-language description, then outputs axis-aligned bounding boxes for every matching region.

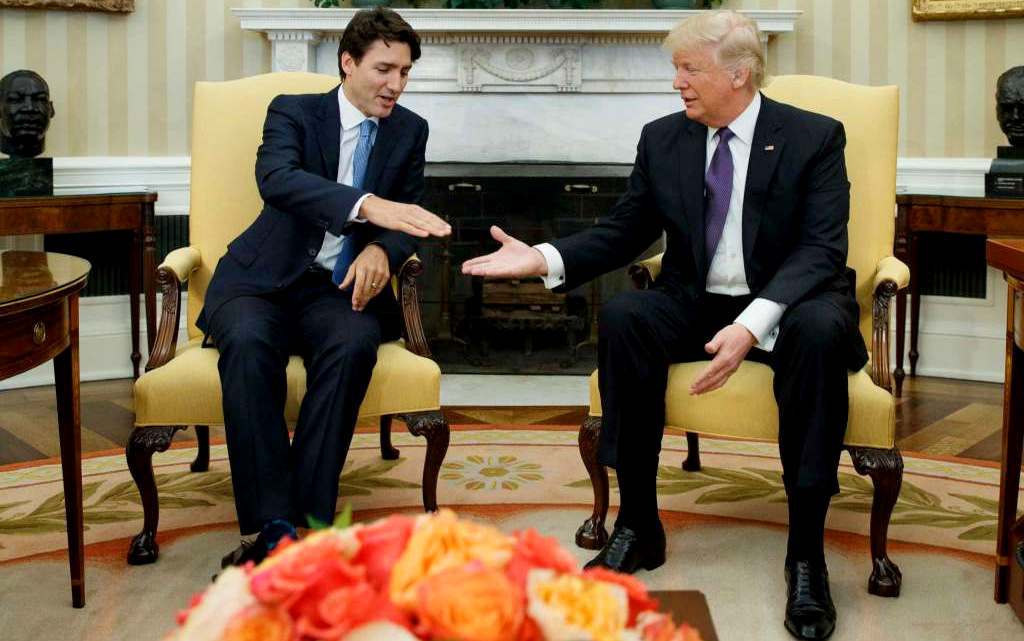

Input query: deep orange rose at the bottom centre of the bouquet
[417,563,525,641]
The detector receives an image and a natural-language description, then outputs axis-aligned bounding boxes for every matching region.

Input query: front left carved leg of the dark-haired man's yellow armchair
[125,425,184,565]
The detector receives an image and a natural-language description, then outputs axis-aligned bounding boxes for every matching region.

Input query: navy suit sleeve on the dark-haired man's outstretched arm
[256,95,366,236]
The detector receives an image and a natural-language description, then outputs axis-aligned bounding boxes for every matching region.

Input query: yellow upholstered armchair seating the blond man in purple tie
[577,76,910,597]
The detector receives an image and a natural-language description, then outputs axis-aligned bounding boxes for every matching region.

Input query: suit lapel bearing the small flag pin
[743,94,785,265]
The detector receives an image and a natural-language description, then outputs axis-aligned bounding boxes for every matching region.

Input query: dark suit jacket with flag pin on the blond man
[553,95,866,365]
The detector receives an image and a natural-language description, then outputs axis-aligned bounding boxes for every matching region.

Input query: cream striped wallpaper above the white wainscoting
[0,0,1024,158]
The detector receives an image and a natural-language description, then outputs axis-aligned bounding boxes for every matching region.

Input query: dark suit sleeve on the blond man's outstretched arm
[552,127,663,291]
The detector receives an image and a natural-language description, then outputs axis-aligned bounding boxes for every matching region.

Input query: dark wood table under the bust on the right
[893,194,1024,397]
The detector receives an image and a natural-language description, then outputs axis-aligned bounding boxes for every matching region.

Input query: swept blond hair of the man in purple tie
[662,10,765,90]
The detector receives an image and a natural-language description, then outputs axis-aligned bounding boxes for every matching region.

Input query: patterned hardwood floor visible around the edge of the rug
[0,378,1002,465]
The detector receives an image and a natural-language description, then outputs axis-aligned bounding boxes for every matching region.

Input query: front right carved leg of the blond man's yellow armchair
[847,447,903,597]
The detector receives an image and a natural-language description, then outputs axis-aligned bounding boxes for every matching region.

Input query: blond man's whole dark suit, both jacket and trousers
[553,95,867,520]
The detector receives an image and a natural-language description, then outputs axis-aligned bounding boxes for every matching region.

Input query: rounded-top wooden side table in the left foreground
[0,252,89,607]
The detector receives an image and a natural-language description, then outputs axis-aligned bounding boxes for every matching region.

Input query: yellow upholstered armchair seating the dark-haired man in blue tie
[126,73,449,564]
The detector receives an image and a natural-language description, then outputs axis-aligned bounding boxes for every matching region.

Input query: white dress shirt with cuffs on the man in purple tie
[535,93,785,351]
